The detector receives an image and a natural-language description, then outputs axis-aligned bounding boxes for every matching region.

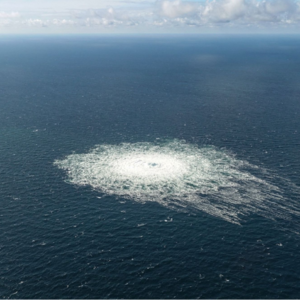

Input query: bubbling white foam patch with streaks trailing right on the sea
[55,140,299,223]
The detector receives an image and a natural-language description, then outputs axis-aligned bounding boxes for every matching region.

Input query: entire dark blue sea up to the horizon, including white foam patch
[0,35,300,300]
